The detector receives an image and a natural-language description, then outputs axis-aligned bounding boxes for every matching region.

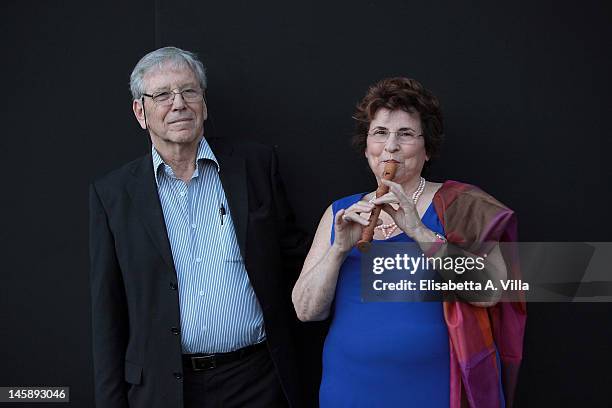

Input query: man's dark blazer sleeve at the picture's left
[89,184,129,408]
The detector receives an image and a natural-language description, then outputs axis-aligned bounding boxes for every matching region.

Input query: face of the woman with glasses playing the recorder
[365,108,429,184]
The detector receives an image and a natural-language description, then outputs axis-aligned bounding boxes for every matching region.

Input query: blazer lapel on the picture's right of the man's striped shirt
[207,138,248,260]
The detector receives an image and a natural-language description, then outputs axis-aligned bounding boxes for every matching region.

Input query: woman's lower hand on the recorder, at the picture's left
[333,200,374,253]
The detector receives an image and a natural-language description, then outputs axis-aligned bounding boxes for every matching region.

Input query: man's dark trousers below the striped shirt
[183,348,288,408]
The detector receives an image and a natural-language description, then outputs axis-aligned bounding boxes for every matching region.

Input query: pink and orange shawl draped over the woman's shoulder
[433,181,527,408]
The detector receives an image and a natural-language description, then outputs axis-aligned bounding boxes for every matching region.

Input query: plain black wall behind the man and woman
[0,0,612,407]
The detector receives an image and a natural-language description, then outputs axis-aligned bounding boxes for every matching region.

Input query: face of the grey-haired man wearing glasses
[132,63,207,148]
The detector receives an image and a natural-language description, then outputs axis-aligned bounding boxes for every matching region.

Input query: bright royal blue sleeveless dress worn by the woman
[319,194,450,408]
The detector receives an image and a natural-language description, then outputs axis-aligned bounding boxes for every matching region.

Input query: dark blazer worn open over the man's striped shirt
[90,139,308,408]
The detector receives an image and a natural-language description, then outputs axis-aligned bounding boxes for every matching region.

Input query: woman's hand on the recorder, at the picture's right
[372,179,424,238]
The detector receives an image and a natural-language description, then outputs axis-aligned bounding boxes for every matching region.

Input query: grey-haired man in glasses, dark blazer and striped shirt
[90,47,307,408]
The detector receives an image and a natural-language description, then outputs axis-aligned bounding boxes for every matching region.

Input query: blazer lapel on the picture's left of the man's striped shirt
[127,154,176,276]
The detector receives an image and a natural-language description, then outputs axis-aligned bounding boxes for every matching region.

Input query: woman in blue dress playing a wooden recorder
[292,78,525,408]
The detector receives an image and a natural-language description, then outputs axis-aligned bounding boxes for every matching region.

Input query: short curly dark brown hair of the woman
[353,77,444,163]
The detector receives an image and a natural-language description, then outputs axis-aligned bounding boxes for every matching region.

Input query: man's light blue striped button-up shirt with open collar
[152,138,266,353]
